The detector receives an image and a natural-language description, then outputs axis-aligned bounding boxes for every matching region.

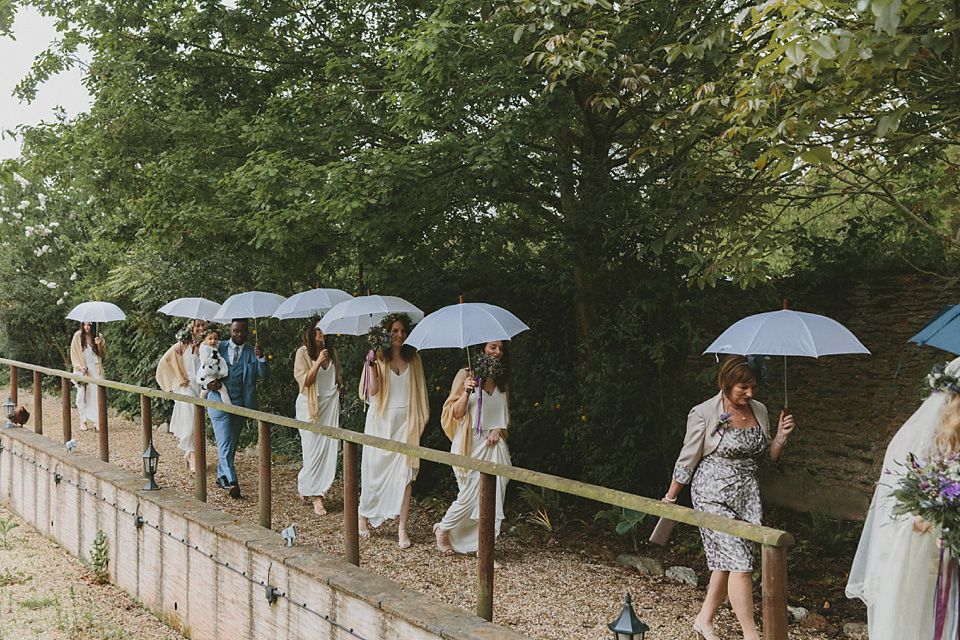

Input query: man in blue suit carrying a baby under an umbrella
[207,319,270,498]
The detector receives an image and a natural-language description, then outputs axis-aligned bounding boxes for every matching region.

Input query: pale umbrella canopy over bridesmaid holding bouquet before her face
[405,302,530,349]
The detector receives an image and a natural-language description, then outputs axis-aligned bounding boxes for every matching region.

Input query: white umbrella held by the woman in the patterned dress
[703,309,870,405]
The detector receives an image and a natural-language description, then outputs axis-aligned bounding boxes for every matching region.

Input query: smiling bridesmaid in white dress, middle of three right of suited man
[358,313,430,549]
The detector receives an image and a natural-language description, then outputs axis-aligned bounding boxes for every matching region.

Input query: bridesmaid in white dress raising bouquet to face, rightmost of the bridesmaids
[433,340,510,554]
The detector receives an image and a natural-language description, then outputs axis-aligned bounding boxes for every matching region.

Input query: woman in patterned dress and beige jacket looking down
[663,355,794,640]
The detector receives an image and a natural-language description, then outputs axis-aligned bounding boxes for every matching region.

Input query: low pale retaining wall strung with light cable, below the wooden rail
[0,429,524,640]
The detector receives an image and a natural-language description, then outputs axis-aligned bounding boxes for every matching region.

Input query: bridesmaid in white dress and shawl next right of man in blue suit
[293,321,343,516]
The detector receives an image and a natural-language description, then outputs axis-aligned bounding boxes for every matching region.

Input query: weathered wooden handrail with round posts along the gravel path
[0,358,793,640]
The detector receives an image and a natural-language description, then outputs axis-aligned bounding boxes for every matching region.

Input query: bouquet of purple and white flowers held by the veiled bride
[893,451,960,559]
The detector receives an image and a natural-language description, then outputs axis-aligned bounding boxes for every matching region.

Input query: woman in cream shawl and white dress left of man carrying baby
[156,318,204,471]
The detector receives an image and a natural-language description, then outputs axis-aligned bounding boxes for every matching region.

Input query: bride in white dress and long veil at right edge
[846,358,960,640]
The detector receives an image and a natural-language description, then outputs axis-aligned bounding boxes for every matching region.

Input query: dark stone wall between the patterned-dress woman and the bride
[761,274,960,518]
